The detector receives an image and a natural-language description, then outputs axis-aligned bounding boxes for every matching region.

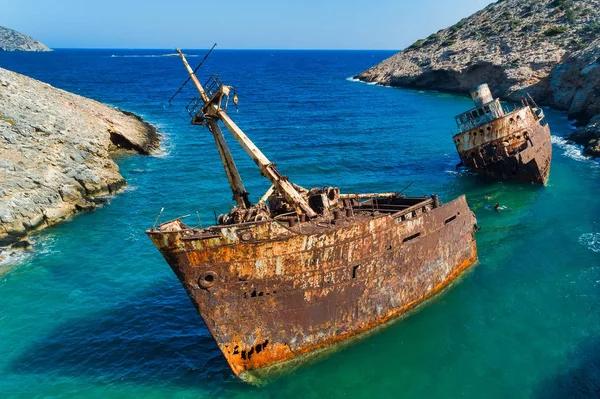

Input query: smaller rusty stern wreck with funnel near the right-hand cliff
[454,84,552,184]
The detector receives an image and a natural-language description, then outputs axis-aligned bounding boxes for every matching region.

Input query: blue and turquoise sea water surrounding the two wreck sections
[0,50,600,399]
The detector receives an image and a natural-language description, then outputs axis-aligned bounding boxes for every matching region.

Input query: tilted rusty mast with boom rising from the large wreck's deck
[177,49,317,218]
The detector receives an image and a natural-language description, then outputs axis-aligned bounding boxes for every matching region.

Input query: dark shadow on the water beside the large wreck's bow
[11,280,243,394]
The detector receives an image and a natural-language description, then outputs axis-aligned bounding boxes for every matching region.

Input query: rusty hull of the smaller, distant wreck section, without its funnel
[454,107,552,184]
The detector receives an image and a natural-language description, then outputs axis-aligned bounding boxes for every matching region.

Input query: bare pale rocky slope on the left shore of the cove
[0,68,159,246]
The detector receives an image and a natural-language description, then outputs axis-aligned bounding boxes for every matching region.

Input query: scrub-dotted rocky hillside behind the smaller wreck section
[357,0,600,155]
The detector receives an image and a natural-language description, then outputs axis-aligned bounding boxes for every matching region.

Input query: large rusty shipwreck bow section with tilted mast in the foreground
[146,50,477,380]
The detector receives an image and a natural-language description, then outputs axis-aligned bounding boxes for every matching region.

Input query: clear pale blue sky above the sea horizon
[0,0,491,49]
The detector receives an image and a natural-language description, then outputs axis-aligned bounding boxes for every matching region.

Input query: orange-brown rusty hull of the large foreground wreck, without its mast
[147,196,477,378]
